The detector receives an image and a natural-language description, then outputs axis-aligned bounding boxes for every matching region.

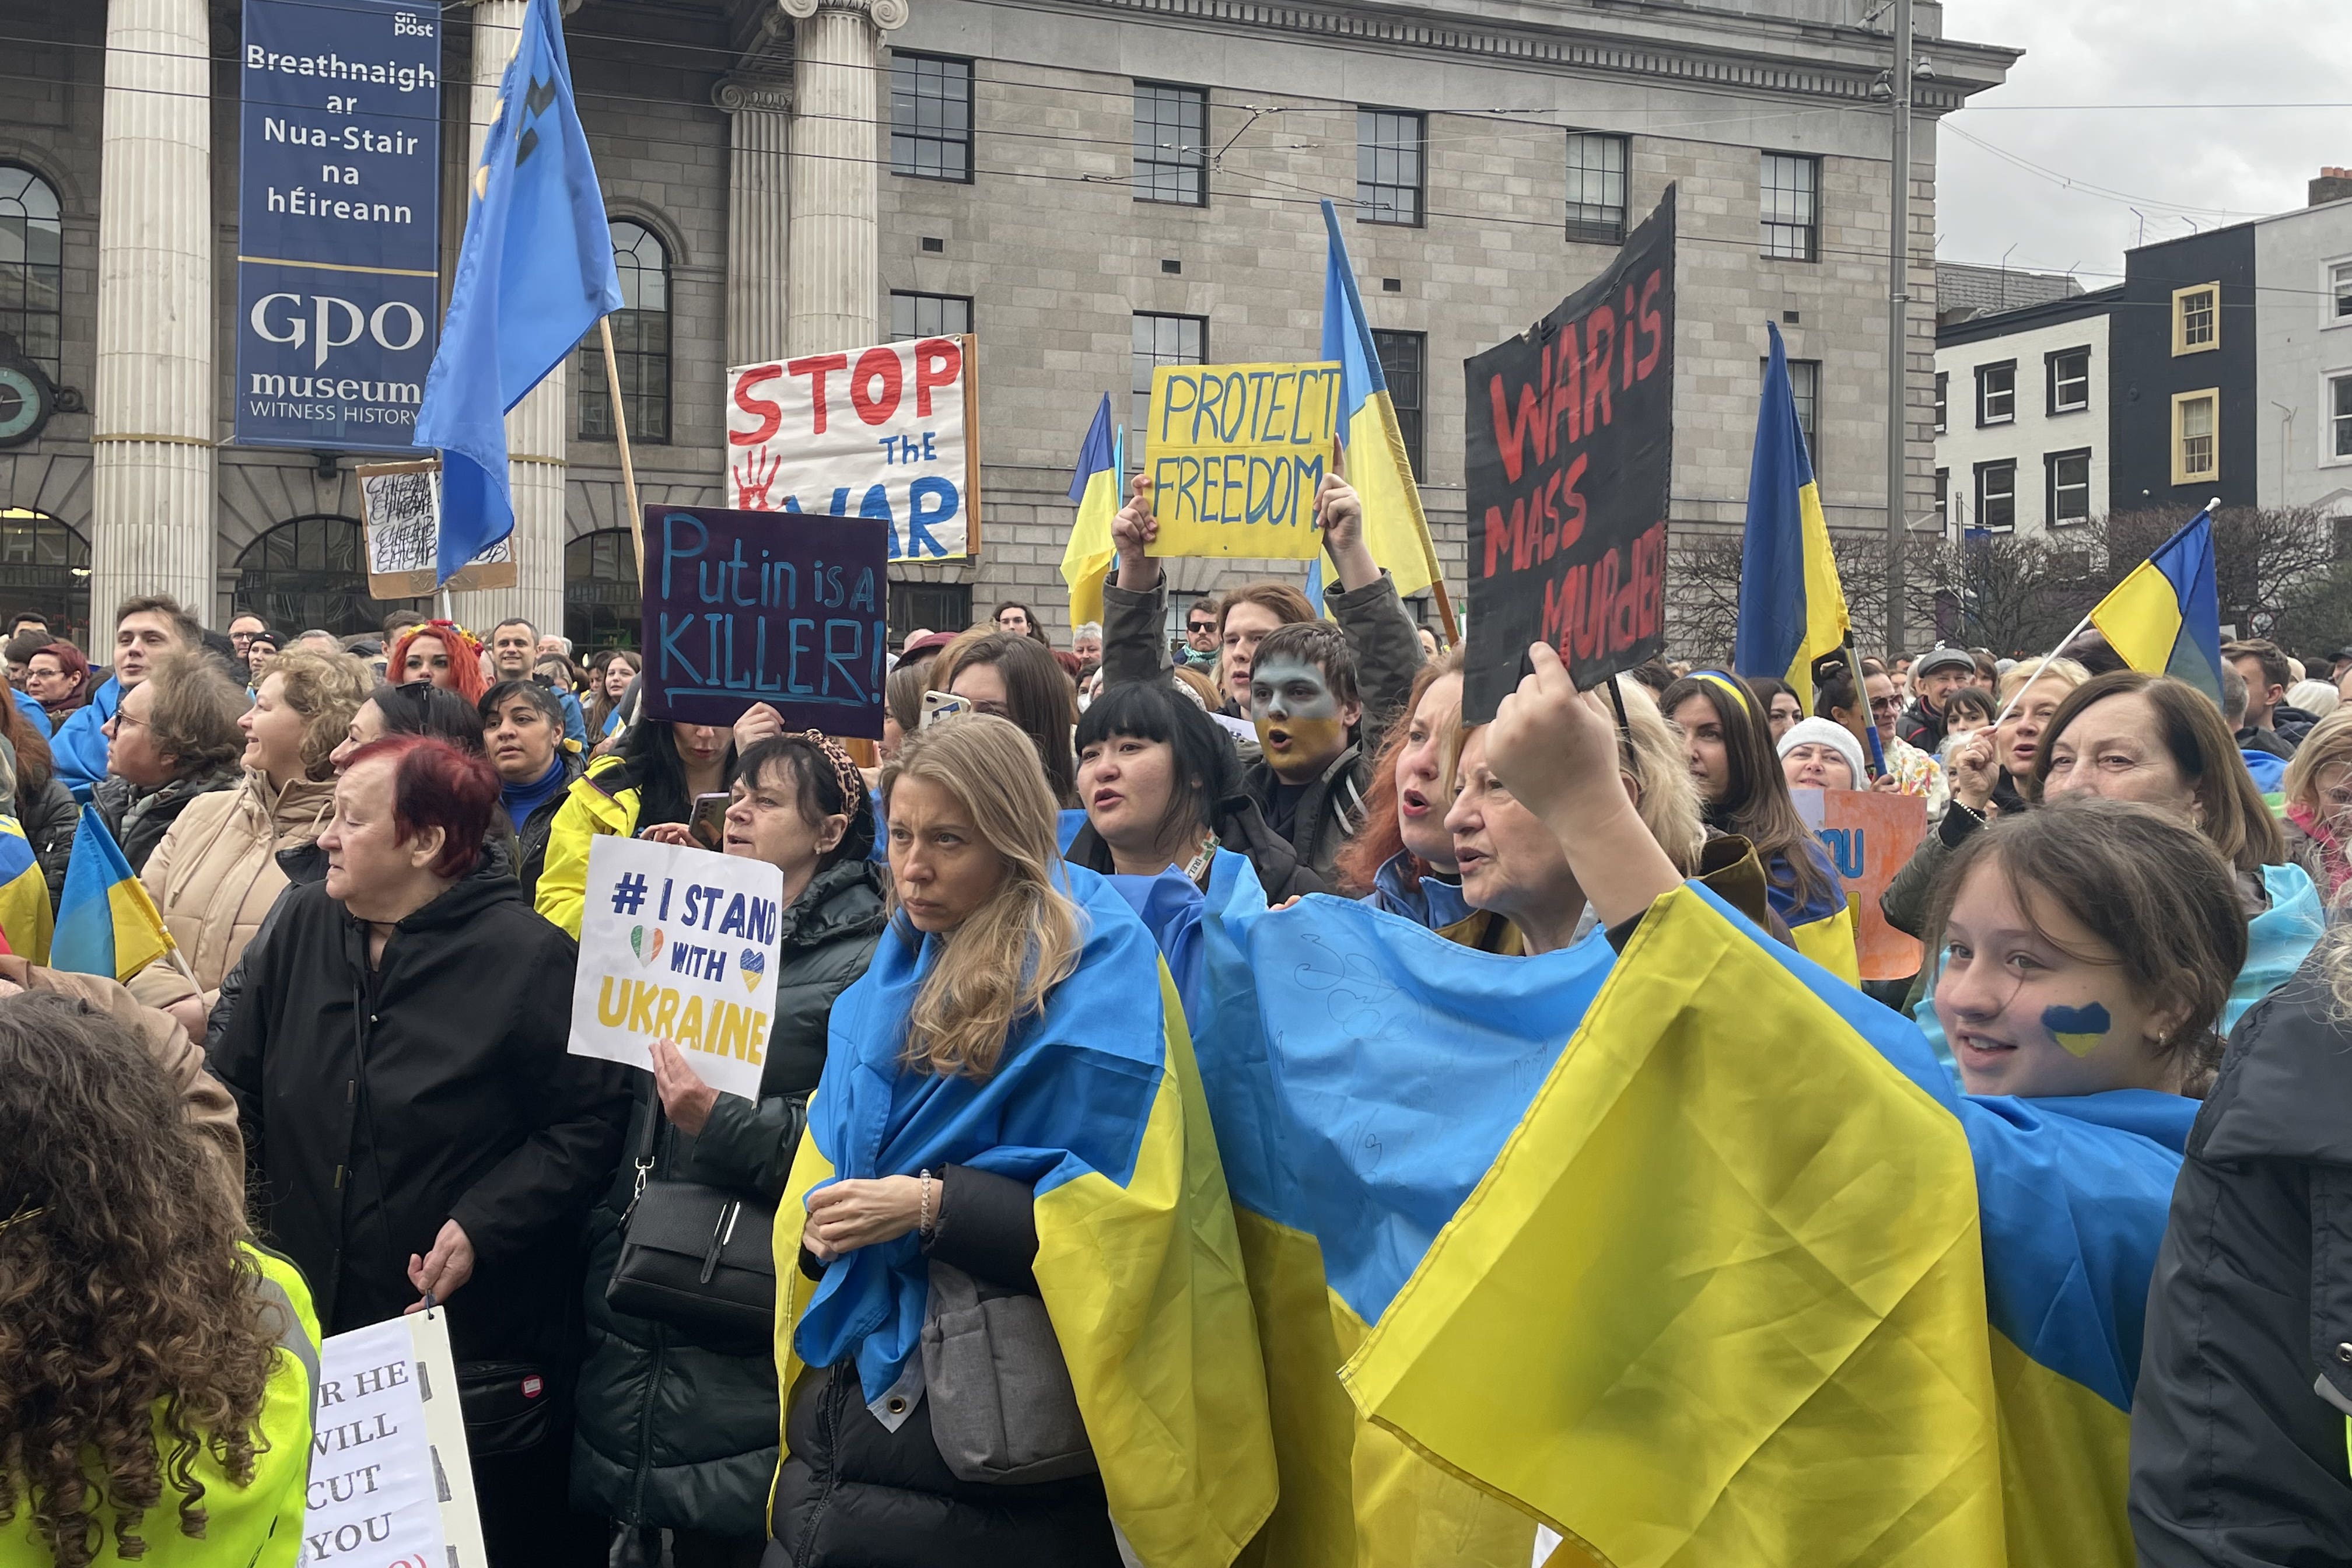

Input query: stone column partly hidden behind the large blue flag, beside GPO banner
[452,0,576,637]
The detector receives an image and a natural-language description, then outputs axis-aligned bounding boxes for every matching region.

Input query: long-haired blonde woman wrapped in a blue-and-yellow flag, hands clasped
[769,715,1275,1568]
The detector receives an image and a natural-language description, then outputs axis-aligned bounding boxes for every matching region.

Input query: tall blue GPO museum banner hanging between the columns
[235,0,442,452]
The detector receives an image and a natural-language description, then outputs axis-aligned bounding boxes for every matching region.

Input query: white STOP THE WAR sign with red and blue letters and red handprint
[727,336,981,562]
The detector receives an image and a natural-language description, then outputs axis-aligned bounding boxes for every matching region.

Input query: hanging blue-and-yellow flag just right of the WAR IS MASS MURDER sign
[1731,322,1849,712]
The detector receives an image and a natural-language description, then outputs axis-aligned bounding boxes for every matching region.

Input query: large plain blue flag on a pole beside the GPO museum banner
[416,0,621,580]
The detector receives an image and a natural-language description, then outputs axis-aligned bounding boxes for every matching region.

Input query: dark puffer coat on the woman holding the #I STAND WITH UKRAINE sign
[572,858,884,1540]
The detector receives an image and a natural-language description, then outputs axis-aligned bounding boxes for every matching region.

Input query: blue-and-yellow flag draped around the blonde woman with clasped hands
[776,856,1279,1568]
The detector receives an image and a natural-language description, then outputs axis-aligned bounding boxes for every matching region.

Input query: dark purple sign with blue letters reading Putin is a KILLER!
[645,505,889,740]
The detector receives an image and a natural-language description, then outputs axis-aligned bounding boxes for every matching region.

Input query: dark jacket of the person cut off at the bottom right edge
[2131,973,2352,1568]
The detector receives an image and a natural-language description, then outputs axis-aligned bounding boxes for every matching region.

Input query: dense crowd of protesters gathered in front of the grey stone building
[13,480,2352,1568]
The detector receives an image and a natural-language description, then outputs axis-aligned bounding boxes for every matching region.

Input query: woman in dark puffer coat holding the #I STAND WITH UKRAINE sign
[572,733,884,1568]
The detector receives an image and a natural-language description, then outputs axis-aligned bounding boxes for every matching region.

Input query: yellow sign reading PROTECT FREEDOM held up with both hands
[1143,365,1338,562]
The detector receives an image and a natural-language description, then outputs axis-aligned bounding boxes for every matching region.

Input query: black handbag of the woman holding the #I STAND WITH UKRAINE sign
[604,1096,776,1345]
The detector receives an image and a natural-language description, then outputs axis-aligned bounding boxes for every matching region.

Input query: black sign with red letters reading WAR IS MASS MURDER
[1463,186,1675,724]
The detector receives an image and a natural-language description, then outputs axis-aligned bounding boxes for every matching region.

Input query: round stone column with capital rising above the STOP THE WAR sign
[781,0,905,355]
